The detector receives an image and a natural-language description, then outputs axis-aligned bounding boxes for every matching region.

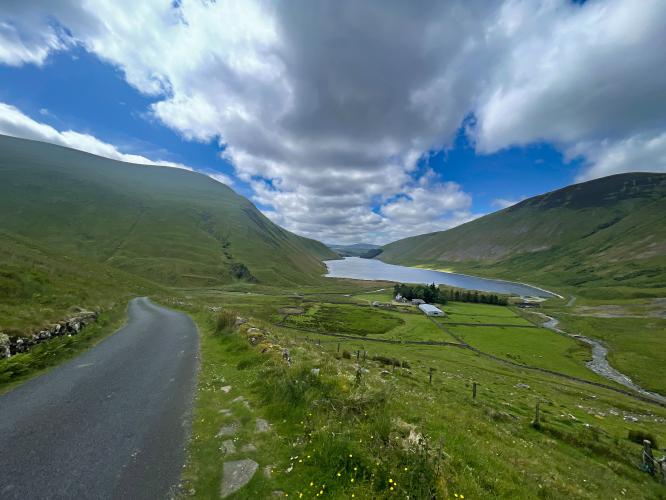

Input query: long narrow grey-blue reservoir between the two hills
[324,257,557,298]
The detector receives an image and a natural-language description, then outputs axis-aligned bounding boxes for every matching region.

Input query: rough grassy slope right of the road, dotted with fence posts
[165,286,666,499]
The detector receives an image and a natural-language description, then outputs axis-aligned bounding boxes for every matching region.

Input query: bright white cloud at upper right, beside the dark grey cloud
[475,0,666,179]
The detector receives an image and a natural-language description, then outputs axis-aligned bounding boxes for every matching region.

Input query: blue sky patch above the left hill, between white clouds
[0,47,239,195]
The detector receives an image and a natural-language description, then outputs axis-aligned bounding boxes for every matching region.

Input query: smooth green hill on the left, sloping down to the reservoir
[0,136,335,292]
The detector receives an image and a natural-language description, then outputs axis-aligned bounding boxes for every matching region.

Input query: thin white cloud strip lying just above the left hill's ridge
[0,102,192,170]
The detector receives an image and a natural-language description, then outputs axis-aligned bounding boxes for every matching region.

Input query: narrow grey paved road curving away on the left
[0,298,198,500]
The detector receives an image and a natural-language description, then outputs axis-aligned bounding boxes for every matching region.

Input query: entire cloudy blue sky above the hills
[0,0,666,244]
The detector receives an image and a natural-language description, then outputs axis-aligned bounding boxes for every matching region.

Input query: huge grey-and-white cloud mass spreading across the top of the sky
[0,0,666,242]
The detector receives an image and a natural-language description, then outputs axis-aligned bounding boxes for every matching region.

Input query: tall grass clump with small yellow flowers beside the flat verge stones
[255,354,445,498]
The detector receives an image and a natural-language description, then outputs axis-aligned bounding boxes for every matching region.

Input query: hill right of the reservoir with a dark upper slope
[378,173,666,294]
